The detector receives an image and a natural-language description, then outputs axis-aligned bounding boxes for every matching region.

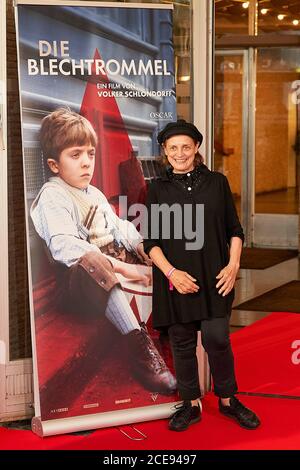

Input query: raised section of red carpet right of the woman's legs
[232,313,300,396]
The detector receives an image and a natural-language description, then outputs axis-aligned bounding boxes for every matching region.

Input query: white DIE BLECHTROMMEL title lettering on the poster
[27,40,171,75]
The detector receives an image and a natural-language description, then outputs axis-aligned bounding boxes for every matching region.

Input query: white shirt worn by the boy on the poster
[30,177,143,266]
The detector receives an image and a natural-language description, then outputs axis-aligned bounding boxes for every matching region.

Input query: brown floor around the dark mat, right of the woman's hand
[230,258,300,332]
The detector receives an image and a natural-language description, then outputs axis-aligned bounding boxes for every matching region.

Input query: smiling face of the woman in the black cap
[163,135,199,173]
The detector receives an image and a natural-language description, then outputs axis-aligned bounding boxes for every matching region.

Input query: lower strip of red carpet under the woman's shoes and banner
[0,393,300,450]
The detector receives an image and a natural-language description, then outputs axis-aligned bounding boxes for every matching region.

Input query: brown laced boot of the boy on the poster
[125,323,176,395]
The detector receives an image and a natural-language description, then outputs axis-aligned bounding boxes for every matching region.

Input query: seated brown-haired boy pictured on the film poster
[30,108,176,395]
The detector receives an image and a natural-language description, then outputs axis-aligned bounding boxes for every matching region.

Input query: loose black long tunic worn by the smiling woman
[144,164,244,329]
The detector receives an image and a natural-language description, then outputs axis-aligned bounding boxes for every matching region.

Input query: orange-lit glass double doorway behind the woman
[214,47,300,248]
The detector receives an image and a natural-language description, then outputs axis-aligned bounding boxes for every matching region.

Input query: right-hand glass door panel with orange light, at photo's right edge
[253,47,300,248]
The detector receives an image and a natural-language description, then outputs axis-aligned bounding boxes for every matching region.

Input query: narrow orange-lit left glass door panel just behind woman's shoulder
[213,50,251,242]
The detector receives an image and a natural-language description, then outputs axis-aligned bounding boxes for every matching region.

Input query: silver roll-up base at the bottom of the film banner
[31,402,180,437]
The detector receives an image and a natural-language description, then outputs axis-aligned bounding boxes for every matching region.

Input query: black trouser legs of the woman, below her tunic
[168,316,237,400]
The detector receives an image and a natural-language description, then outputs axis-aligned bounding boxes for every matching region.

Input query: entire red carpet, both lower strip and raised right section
[0,313,300,450]
